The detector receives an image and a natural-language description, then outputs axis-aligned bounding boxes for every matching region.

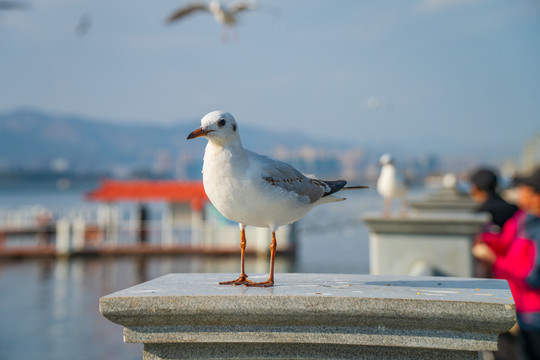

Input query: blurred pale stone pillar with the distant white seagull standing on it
[364,213,489,277]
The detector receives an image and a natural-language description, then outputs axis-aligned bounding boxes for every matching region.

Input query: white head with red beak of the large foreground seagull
[187,110,241,146]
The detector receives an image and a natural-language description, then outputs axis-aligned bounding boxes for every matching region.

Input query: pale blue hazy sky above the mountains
[0,0,540,159]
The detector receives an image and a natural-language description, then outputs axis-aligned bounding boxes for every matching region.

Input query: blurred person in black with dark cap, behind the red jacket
[469,168,518,229]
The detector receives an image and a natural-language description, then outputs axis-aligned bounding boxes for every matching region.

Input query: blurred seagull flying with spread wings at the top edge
[165,0,256,40]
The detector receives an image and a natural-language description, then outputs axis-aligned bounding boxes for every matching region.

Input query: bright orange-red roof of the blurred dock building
[86,179,209,210]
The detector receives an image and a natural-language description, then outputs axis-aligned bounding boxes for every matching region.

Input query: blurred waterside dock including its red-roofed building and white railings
[0,180,296,259]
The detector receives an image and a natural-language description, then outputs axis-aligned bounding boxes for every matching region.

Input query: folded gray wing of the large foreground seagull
[254,154,331,203]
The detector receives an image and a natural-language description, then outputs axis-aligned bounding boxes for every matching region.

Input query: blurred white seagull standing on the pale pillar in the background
[377,154,407,216]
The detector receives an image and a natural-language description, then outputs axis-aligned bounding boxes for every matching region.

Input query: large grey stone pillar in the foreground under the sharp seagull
[97,274,515,360]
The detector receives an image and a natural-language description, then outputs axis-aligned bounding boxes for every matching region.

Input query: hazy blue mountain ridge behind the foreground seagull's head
[0,109,360,176]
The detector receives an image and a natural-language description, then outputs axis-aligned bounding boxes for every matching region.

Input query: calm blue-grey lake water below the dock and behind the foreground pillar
[0,183,408,360]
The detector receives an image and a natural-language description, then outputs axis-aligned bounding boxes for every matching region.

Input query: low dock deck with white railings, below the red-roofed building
[0,221,296,259]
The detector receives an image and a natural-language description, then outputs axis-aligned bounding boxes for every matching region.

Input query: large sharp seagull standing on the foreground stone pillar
[187,111,366,287]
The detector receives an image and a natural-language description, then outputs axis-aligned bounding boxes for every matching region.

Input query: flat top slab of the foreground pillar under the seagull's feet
[100,273,514,302]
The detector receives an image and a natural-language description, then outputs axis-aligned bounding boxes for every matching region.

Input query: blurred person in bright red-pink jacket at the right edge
[473,168,540,359]
